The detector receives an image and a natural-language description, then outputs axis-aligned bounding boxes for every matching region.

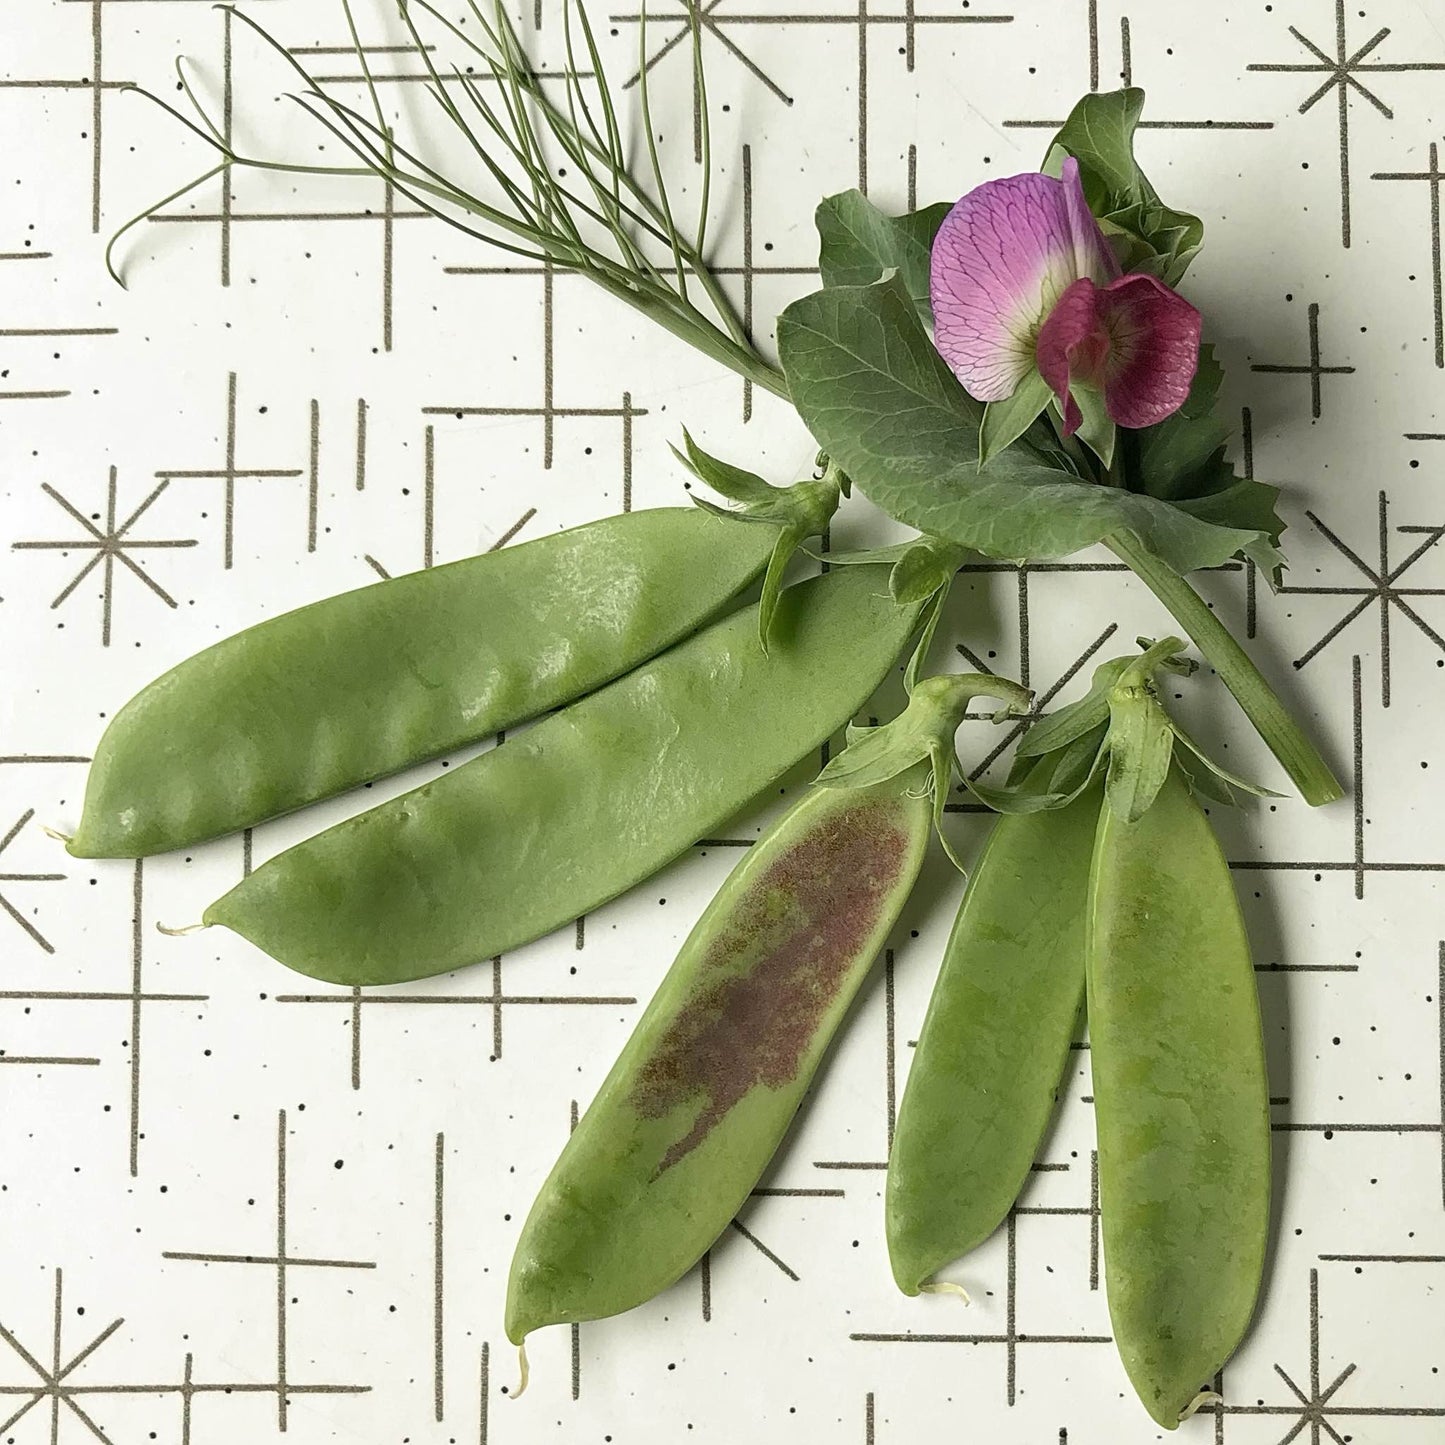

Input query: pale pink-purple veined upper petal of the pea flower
[929,156,1118,402]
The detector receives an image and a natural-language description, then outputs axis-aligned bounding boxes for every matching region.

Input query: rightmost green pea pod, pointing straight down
[1087,770,1270,1429]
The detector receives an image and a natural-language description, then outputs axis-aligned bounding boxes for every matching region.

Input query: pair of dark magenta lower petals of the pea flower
[1036,276,1199,436]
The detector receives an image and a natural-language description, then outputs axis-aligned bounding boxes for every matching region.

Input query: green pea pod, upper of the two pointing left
[69,480,838,858]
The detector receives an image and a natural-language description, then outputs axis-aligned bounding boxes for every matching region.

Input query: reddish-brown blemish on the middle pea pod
[631,798,910,1175]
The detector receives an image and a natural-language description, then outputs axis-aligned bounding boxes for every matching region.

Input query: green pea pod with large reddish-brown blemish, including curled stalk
[506,676,1027,1344]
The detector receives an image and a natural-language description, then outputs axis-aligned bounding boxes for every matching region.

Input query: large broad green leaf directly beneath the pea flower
[777,276,1272,572]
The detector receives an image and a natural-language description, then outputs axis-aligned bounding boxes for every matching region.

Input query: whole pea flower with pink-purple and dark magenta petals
[929,156,1199,439]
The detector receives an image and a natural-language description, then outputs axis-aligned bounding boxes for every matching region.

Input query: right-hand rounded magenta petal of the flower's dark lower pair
[1098,276,1199,426]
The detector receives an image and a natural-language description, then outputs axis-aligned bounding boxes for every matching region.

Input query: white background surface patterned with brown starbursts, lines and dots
[0,0,1445,1445]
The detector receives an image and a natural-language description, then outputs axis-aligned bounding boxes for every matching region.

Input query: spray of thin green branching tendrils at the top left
[105,0,788,397]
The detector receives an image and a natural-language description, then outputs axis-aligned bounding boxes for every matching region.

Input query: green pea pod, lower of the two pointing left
[204,568,919,984]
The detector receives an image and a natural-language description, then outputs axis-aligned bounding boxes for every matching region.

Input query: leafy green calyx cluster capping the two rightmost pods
[999,637,1279,822]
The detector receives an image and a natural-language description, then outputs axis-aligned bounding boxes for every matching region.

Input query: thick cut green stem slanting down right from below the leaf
[1104,532,1344,808]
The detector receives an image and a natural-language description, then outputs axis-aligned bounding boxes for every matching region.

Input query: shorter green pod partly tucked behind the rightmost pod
[886,786,1100,1295]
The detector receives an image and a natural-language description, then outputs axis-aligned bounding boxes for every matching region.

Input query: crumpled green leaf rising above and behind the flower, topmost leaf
[1043,87,1204,286]
